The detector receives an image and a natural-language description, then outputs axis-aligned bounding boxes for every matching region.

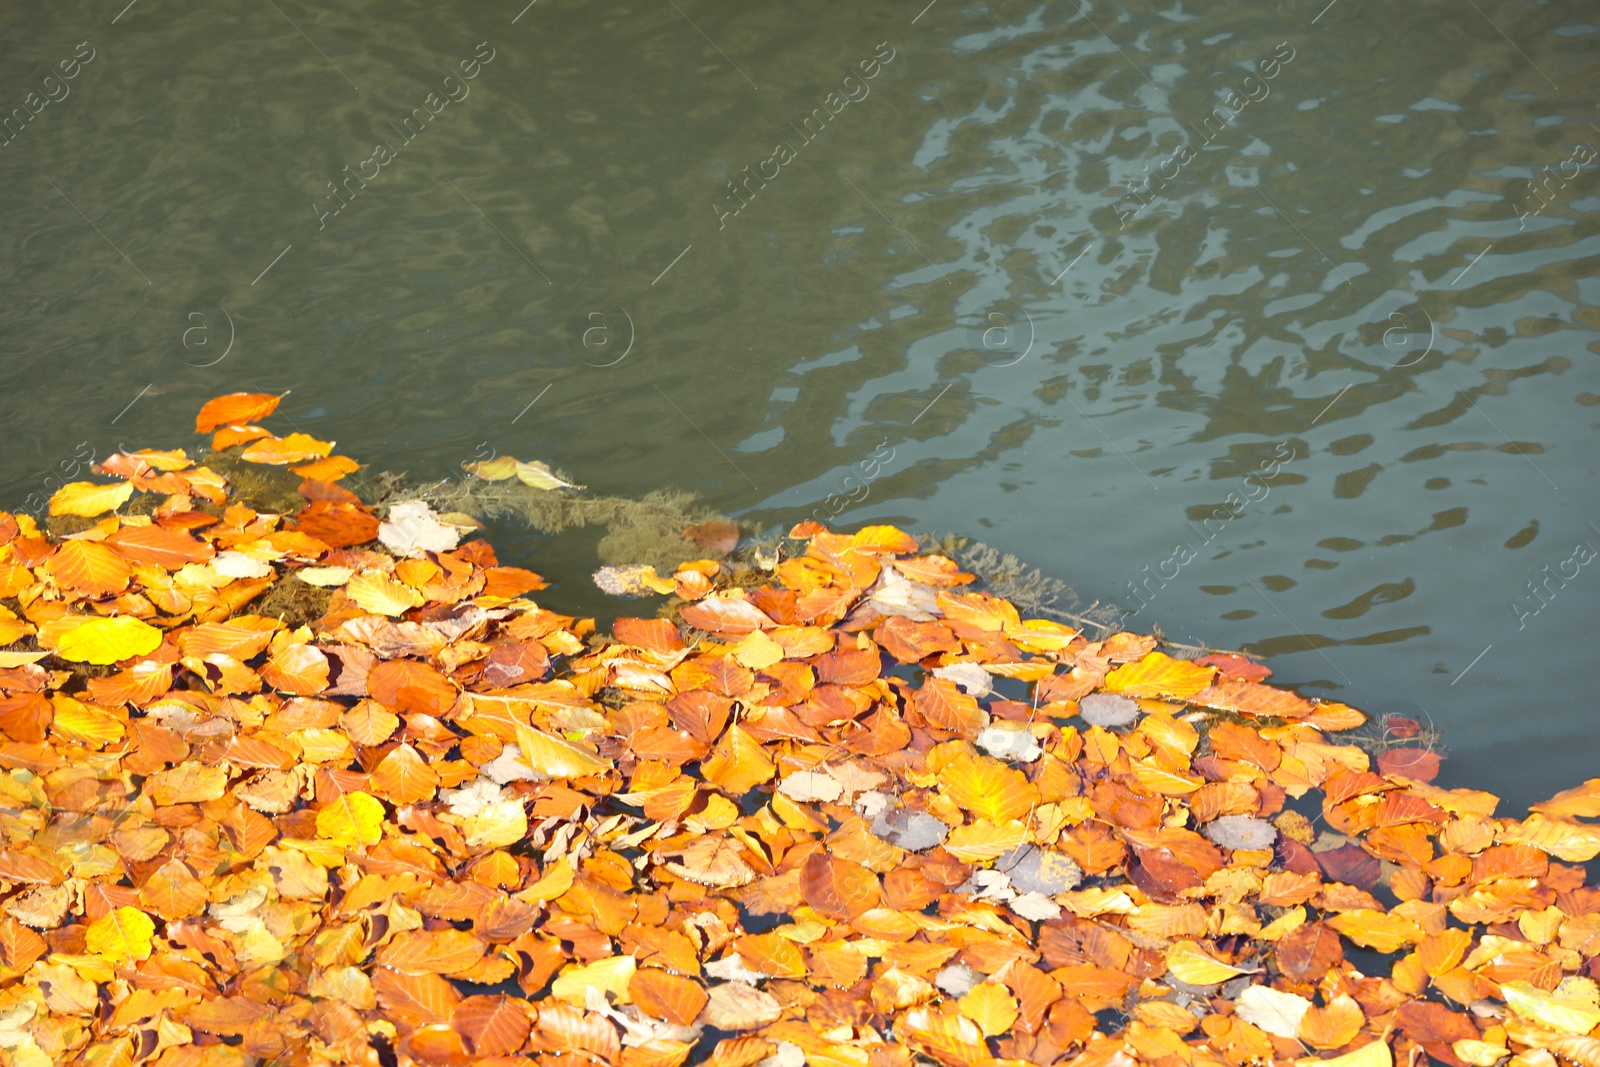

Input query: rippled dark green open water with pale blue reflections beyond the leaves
[0,0,1600,809]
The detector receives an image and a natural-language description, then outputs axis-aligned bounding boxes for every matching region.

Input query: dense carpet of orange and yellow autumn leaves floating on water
[0,395,1600,1067]
